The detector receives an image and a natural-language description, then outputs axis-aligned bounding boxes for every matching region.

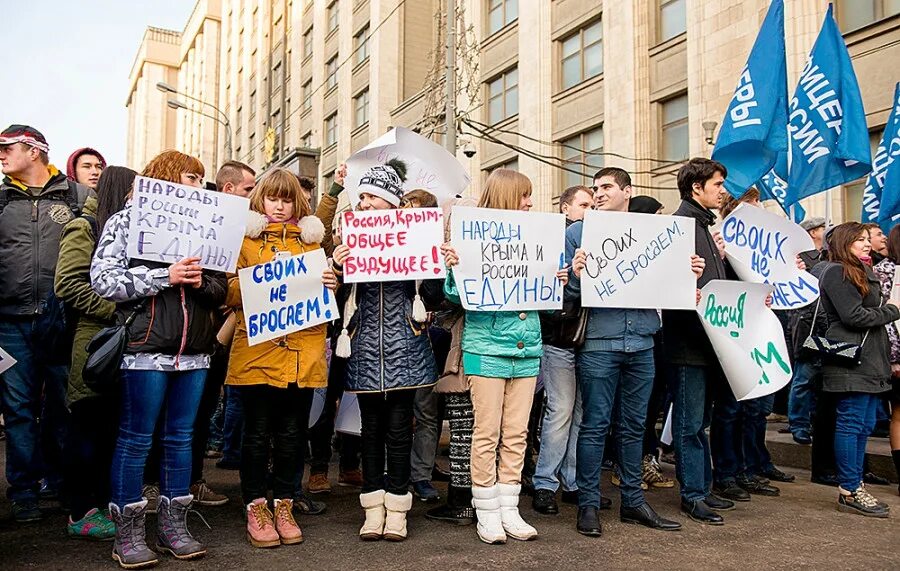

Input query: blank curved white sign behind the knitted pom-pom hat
[344,127,471,206]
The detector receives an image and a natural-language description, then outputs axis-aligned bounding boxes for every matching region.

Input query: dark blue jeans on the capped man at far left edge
[0,305,71,501]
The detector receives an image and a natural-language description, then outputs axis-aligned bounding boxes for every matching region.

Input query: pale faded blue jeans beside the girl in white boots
[532,345,582,492]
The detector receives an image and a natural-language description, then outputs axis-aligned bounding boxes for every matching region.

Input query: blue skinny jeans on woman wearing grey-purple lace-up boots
[110,369,206,507]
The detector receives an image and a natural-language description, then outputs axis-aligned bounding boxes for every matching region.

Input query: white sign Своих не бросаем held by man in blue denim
[581,210,697,309]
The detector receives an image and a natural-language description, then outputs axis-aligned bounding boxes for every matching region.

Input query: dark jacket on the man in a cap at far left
[0,165,93,317]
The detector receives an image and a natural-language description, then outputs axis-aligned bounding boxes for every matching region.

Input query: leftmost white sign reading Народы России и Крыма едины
[127,176,250,272]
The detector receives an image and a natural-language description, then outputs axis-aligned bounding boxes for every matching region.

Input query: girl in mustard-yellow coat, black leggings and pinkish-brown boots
[225,169,337,547]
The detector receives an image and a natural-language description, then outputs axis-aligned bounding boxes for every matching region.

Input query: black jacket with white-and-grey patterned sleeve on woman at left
[91,205,227,370]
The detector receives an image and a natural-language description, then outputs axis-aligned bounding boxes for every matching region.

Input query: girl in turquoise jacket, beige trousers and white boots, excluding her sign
[442,169,568,543]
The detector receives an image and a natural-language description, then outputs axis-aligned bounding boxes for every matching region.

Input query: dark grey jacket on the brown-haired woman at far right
[819,262,900,393]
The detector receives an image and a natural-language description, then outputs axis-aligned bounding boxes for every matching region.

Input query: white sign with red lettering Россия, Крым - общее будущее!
[341,208,447,283]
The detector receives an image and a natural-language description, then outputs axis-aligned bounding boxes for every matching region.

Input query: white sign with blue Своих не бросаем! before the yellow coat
[238,249,338,345]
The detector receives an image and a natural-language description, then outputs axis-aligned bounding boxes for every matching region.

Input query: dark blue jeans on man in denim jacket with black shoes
[575,349,653,507]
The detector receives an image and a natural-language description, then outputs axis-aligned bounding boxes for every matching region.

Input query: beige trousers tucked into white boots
[469,375,537,488]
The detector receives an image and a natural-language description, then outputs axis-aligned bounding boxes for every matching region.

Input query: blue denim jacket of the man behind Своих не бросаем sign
[564,222,659,353]
